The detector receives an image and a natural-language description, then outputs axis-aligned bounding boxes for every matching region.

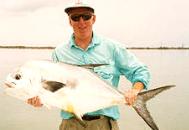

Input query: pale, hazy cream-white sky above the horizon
[0,0,189,47]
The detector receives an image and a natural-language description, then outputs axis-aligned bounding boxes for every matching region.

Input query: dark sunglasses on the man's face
[70,14,93,22]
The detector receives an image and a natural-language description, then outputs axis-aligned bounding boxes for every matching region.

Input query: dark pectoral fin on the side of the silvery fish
[42,80,66,92]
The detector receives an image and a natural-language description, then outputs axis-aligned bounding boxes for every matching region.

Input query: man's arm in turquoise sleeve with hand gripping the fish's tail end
[114,46,150,105]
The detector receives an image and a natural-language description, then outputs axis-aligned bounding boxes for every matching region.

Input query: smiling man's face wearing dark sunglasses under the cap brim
[69,8,96,38]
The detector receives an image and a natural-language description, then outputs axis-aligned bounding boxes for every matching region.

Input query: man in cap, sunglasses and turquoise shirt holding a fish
[28,2,150,130]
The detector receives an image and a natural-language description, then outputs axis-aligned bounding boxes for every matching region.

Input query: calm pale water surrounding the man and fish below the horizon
[0,49,189,130]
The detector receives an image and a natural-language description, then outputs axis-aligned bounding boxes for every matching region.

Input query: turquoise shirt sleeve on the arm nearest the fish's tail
[114,47,150,89]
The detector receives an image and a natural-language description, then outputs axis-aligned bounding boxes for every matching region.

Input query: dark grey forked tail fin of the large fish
[133,85,175,130]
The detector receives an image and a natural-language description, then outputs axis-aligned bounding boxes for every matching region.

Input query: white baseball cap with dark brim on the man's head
[64,1,94,14]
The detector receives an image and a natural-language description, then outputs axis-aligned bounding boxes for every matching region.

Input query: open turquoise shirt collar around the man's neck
[69,33,100,49]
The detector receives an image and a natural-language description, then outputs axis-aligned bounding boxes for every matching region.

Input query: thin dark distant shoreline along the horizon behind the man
[0,46,189,50]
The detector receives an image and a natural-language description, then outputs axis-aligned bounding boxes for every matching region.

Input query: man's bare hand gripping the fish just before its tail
[125,82,144,106]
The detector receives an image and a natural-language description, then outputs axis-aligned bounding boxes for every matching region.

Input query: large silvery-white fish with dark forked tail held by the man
[4,60,175,130]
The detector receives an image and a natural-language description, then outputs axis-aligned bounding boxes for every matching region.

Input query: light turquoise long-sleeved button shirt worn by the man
[52,33,150,120]
